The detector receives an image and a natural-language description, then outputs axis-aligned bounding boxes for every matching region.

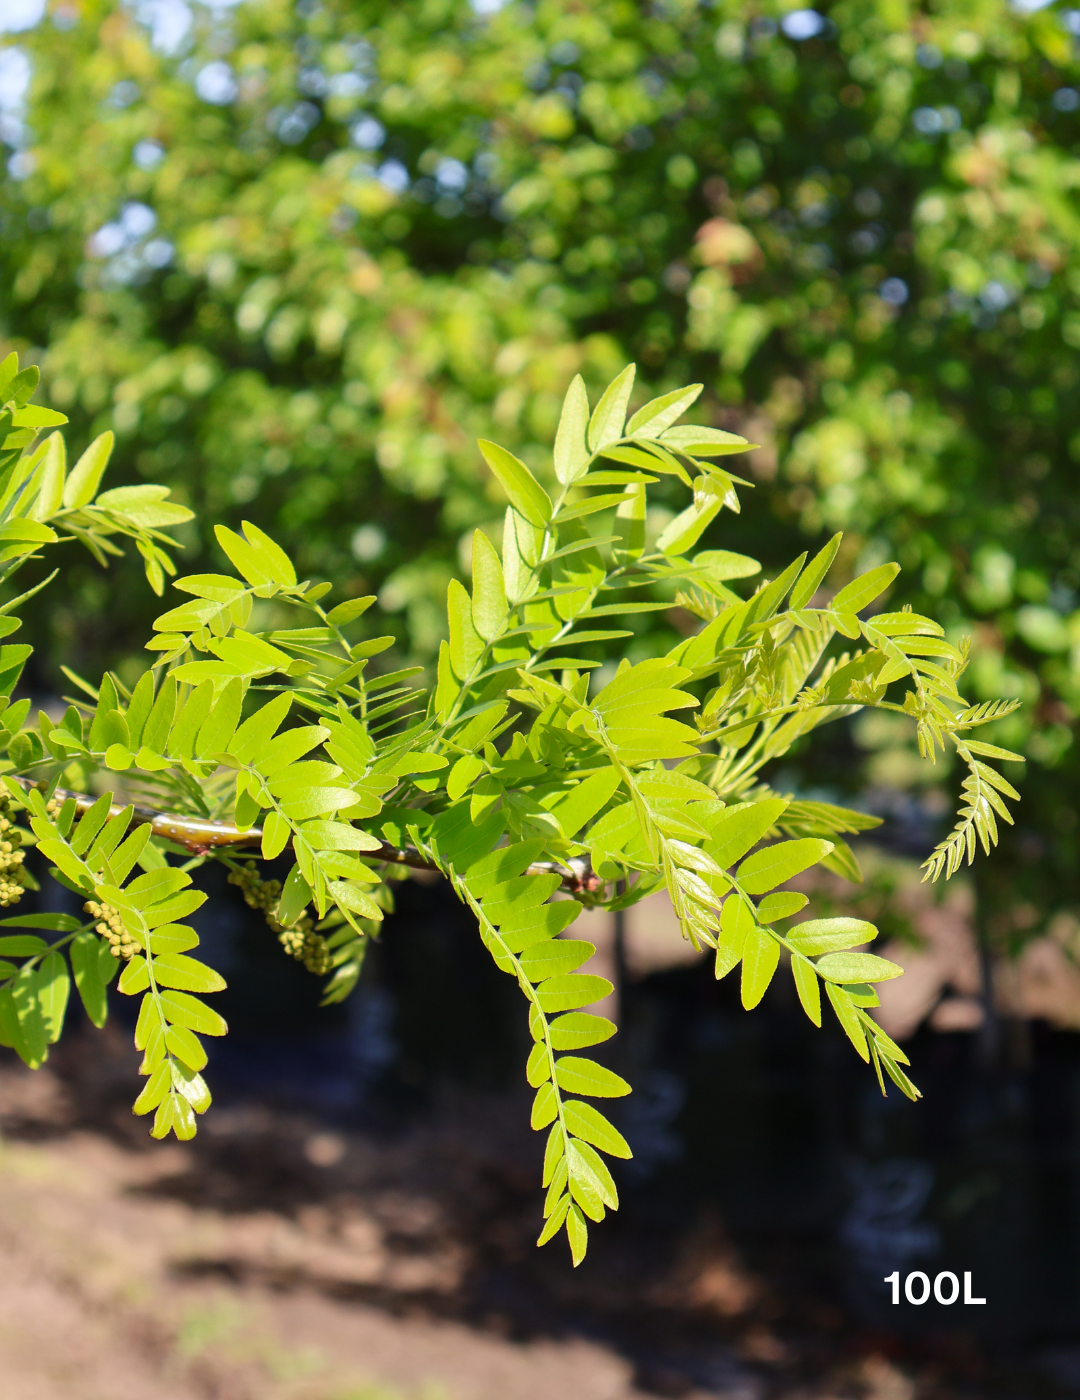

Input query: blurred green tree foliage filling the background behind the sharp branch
[0,0,1080,941]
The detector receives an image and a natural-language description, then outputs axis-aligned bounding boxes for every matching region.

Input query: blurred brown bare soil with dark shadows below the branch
[0,1030,1055,1400]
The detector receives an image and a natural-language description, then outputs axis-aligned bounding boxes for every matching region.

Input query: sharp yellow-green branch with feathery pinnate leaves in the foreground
[0,356,1016,1263]
